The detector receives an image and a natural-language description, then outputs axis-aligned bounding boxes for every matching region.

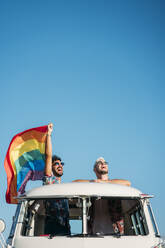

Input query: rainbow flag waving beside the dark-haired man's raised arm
[4,126,47,203]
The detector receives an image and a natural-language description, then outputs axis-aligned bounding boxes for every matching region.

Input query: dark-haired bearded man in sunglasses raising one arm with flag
[43,123,70,235]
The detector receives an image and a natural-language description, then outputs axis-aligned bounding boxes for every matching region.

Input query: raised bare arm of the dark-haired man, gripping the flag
[44,123,53,176]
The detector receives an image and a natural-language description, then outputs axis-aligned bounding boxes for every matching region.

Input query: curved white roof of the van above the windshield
[19,182,142,199]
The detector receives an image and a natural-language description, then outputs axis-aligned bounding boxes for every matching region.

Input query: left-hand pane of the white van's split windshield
[22,198,82,236]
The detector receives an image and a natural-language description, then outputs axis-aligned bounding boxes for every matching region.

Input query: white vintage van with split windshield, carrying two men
[0,182,164,248]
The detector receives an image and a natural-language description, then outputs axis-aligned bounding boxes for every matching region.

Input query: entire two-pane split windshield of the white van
[22,197,148,236]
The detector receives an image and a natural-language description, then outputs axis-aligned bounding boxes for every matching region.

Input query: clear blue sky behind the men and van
[0,0,165,237]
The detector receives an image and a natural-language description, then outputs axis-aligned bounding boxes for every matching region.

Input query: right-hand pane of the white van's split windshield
[88,197,148,235]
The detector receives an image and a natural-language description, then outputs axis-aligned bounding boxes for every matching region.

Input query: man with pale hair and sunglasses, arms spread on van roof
[75,157,131,234]
